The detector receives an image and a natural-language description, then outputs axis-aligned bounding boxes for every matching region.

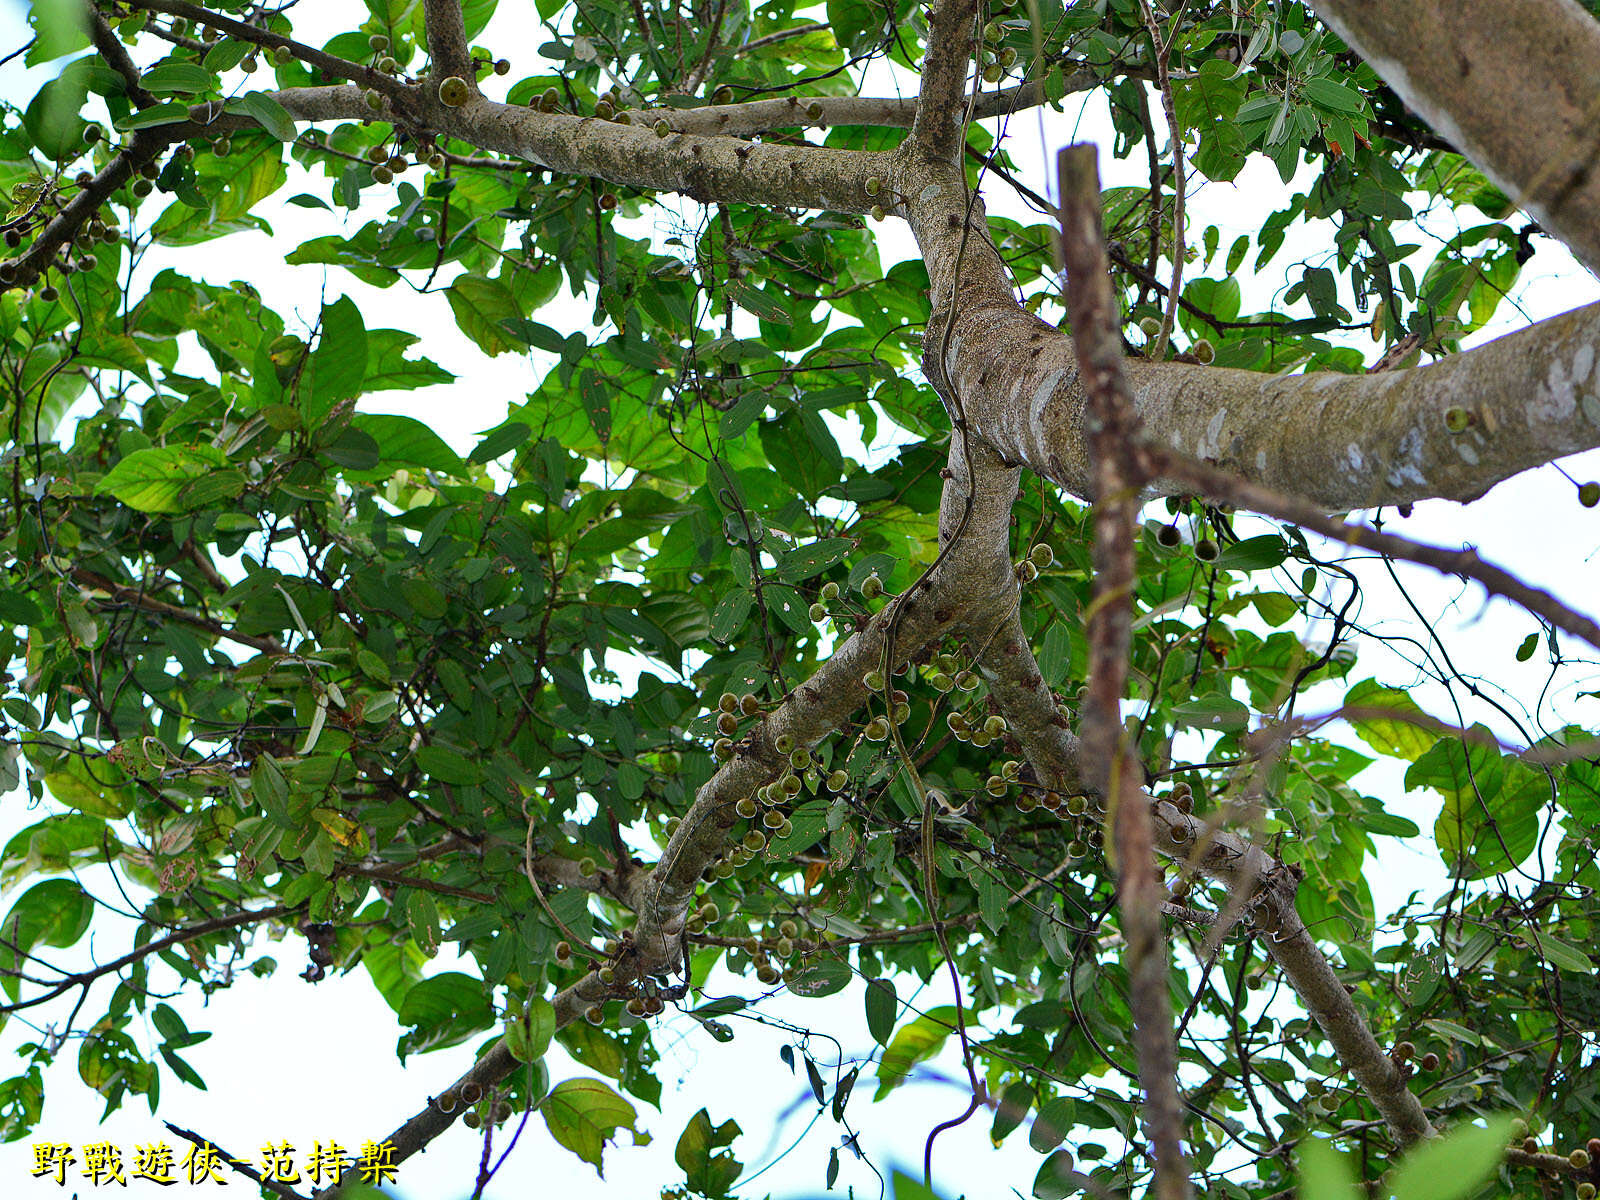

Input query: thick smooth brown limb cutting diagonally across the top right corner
[1312,0,1600,274]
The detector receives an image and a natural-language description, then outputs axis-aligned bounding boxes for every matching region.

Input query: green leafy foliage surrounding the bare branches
[0,0,1600,1197]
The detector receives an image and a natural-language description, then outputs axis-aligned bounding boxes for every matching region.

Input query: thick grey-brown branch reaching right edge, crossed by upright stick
[930,281,1600,512]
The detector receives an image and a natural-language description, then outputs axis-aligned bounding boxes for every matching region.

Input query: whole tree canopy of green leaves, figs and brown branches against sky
[0,0,1600,1200]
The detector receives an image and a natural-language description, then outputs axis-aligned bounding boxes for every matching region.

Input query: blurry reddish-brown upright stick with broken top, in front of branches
[1059,146,1192,1200]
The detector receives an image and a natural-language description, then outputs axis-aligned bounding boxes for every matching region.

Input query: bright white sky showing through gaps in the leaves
[0,0,1600,1200]
